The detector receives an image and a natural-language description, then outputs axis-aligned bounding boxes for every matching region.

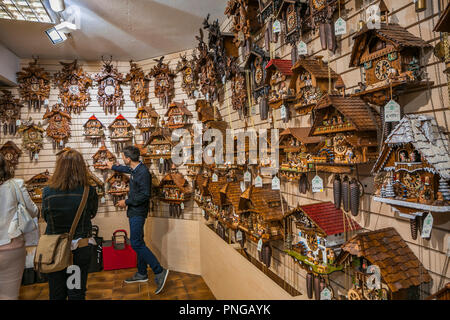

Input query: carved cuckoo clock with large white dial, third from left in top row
[95,58,124,114]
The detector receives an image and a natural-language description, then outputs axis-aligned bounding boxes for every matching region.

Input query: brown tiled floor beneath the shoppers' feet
[19,269,215,300]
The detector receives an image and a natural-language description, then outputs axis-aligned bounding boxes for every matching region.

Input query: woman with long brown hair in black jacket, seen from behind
[42,148,98,300]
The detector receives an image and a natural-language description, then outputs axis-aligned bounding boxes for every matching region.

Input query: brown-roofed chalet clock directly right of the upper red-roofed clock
[289,56,344,115]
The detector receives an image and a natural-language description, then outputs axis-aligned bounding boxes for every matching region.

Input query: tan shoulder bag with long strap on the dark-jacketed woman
[34,187,89,273]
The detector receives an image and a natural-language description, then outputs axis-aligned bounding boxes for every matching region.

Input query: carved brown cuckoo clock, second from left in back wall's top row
[54,60,92,114]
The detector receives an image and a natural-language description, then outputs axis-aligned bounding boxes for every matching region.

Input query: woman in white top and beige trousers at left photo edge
[0,154,38,300]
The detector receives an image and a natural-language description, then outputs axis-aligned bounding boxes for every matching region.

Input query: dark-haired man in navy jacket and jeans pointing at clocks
[107,146,169,294]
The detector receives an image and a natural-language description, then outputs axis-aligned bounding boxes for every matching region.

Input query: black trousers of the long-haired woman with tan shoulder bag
[48,245,91,300]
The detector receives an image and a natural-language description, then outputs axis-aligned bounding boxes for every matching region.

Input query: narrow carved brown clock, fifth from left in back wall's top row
[147,56,176,108]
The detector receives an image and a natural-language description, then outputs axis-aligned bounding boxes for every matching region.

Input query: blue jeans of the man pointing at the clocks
[130,216,163,275]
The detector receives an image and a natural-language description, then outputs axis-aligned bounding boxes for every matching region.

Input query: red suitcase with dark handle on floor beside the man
[103,230,137,270]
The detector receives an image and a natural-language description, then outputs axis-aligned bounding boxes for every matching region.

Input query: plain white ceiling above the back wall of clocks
[0,0,227,61]
